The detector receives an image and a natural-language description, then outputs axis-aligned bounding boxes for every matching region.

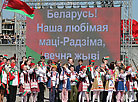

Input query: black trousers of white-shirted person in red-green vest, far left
[7,85,17,102]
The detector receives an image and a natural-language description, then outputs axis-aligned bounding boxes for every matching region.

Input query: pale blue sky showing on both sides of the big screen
[0,0,138,21]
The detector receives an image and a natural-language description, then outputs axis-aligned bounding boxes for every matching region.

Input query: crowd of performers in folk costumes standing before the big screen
[0,55,138,102]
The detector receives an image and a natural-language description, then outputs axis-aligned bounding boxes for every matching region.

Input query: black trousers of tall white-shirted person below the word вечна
[37,82,45,102]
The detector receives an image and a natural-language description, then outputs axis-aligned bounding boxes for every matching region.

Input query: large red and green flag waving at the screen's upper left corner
[3,0,34,19]
